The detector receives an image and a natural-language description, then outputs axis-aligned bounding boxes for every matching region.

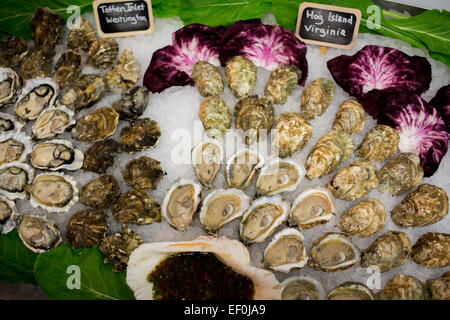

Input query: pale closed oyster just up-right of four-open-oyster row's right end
[327,160,378,201]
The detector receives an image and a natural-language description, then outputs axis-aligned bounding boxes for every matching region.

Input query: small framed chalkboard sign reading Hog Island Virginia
[295,2,361,49]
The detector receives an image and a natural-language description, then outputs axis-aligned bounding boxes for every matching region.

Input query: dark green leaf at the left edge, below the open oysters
[0,229,37,284]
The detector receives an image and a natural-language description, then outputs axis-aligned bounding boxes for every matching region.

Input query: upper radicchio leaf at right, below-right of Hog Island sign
[327,45,431,99]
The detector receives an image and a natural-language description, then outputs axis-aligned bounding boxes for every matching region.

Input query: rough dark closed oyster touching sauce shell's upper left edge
[98,224,144,271]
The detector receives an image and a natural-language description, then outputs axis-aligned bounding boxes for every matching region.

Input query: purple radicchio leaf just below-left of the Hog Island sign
[219,19,308,85]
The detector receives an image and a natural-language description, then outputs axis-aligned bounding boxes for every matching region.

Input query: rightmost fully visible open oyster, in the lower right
[308,232,359,272]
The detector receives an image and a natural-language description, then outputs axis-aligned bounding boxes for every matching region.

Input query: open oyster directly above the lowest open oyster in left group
[30,172,78,212]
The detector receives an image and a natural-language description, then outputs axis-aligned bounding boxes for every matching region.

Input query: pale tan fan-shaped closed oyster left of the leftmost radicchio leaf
[105,49,140,91]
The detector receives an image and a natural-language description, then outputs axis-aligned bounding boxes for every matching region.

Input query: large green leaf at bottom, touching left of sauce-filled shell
[34,245,134,300]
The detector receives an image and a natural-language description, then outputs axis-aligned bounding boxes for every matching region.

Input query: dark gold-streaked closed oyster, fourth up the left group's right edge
[120,118,161,154]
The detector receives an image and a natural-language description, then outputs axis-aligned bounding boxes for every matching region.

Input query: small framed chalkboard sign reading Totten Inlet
[92,0,154,38]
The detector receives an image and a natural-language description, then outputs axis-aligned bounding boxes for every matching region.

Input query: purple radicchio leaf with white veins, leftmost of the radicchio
[144,24,224,92]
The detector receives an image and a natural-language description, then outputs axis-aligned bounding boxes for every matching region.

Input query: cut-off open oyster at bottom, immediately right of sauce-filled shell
[281,276,326,300]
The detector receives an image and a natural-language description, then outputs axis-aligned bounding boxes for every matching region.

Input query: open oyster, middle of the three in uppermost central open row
[225,149,264,189]
